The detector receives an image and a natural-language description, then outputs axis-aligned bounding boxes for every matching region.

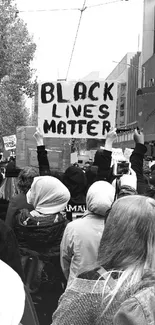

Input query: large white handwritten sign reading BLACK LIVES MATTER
[38,81,117,139]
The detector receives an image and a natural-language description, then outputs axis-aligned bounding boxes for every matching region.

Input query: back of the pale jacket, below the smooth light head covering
[61,212,104,284]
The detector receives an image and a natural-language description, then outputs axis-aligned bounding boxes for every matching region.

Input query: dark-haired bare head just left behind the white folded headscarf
[17,167,39,194]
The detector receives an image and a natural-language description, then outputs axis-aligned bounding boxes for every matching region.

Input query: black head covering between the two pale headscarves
[63,166,87,204]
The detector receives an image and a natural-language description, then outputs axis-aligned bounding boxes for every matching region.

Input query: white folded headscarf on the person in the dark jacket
[26,176,70,214]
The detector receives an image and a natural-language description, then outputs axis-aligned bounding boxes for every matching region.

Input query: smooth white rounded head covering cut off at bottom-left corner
[0,260,25,325]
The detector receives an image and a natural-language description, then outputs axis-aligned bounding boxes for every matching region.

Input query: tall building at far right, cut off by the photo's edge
[137,0,155,157]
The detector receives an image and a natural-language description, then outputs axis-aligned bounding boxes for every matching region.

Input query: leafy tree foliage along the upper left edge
[0,0,36,135]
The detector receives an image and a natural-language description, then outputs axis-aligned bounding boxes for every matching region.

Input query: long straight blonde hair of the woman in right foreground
[98,195,155,314]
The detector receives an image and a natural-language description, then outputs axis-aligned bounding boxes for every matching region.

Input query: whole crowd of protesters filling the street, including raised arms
[0,129,155,325]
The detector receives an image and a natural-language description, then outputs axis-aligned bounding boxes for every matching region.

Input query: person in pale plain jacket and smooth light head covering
[60,181,115,286]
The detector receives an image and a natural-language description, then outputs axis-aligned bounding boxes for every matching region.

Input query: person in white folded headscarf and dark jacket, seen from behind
[14,176,70,325]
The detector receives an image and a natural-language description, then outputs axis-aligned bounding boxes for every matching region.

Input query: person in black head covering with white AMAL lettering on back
[63,166,87,221]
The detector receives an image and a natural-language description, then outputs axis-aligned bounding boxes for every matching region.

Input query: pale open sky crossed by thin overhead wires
[15,0,143,81]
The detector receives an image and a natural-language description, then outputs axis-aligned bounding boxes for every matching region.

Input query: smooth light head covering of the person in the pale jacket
[86,181,115,216]
